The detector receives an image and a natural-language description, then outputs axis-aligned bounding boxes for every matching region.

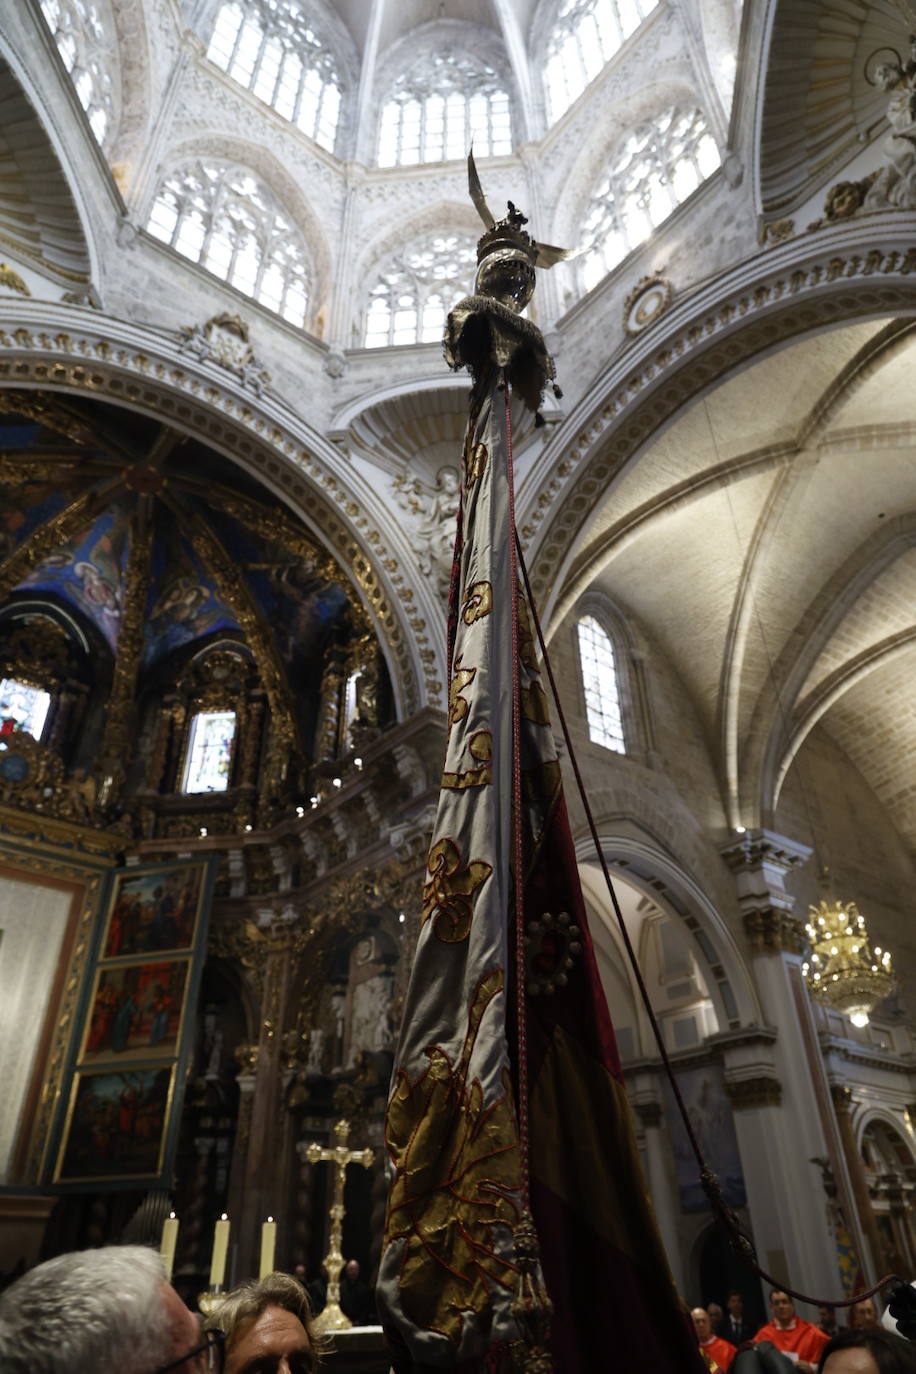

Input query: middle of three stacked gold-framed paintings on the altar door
[80,958,191,1063]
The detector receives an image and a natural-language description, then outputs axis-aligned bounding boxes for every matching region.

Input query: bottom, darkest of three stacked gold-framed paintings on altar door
[54,1065,176,1183]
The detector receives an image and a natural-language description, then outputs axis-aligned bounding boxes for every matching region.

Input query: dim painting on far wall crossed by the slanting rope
[666,1063,747,1212]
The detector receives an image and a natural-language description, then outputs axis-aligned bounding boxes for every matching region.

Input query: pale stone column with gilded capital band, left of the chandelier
[722,830,851,1315]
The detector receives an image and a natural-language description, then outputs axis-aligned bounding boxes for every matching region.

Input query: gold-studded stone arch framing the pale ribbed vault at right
[538,230,916,625]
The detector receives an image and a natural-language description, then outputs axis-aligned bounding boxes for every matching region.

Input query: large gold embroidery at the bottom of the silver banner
[385,972,519,1345]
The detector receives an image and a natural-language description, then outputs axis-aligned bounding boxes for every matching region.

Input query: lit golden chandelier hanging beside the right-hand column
[802,901,895,1026]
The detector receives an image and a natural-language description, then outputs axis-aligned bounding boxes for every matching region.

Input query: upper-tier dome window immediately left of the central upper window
[207,0,342,153]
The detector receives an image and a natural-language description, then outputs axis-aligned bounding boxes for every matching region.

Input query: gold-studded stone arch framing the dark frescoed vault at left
[0,302,444,719]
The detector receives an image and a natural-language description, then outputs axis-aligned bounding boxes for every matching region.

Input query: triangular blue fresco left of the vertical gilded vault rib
[19,507,130,650]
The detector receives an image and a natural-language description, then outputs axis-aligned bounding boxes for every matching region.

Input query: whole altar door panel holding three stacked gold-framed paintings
[45,859,214,1189]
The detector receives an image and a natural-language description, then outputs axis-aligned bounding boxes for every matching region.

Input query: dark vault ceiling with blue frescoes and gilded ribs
[0,392,365,723]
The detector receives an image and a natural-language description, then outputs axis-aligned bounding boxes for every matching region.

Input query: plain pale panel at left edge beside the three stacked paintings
[0,870,78,1183]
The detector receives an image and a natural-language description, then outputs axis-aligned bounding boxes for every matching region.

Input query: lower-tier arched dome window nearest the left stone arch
[147,162,309,326]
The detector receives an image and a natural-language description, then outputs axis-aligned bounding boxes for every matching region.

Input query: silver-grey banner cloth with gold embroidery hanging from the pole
[378,386,520,1366]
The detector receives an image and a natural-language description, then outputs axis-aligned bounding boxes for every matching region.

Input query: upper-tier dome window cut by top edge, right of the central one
[544,0,658,124]
